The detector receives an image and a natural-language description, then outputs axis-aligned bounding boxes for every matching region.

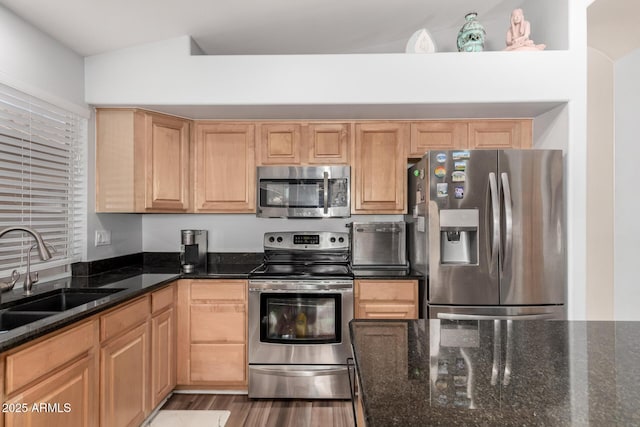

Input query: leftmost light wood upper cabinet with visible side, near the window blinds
[96,109,190,212]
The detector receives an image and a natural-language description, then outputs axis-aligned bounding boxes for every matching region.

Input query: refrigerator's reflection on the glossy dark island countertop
[429,320,571,413]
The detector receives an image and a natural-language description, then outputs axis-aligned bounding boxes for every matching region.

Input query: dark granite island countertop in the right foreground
[350,320,640,427]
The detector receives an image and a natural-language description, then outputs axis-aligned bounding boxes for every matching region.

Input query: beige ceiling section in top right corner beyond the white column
[587,0,640,61]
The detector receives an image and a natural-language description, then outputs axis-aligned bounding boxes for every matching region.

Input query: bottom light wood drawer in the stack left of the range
[191,344,247,383]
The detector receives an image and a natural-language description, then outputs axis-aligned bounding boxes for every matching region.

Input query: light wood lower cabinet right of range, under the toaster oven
[354,279,419,319]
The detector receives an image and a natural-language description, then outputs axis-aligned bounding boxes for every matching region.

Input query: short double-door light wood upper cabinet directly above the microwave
[257,122,351,165]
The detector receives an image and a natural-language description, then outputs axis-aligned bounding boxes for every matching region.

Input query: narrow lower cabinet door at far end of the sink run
[151,308,176,408]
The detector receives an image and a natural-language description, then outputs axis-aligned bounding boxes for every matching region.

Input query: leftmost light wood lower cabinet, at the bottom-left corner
[3,320,98,427]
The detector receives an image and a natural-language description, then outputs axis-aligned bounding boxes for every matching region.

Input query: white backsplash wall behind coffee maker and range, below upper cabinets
[142,214,403,252]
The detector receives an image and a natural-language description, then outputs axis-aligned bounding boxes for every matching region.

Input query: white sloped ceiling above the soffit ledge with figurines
[0,0,516,56]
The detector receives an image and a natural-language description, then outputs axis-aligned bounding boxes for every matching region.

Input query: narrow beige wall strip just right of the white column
[587,49,615,320]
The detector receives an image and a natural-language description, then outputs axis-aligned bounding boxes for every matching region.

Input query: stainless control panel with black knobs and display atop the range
[264,231,349,250]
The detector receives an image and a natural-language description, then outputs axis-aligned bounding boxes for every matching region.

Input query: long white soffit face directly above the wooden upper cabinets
[85,36,575,106]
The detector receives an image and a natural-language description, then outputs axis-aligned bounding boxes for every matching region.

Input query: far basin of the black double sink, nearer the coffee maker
[7,288,122,313]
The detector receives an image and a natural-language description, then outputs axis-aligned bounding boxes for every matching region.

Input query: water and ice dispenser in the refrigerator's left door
[440,209,479,265]
